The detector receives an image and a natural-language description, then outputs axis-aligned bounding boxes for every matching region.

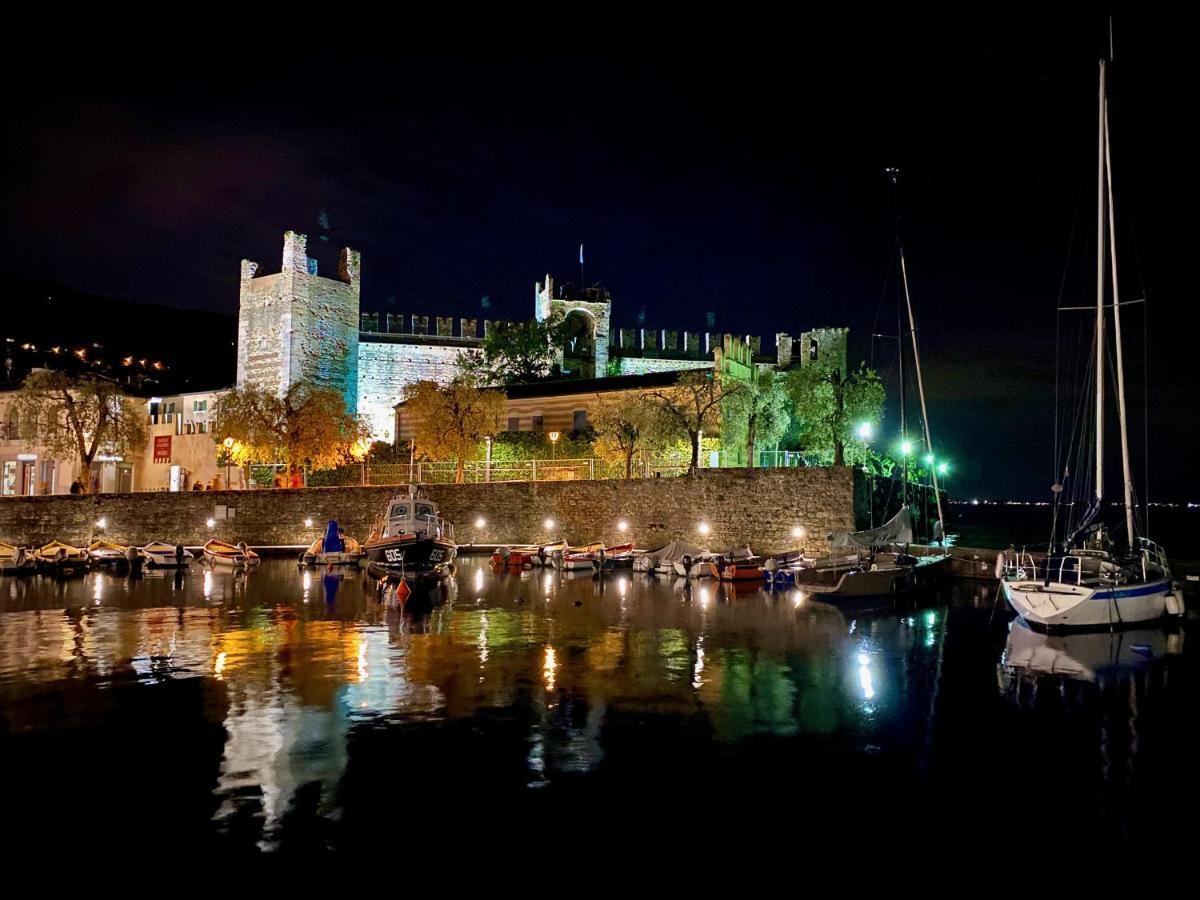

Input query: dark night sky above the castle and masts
[0,11,1200,499]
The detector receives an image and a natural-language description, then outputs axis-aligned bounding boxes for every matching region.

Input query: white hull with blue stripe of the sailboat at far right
[1002,578,1171,629]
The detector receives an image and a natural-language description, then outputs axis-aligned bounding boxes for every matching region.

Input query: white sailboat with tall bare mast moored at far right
[1001,60,1183,629]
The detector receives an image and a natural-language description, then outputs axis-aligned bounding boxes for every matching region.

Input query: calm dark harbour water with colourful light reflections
[0,559,1200,857]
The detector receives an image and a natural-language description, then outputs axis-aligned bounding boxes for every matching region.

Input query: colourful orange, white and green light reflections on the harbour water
[0,559,1183,848]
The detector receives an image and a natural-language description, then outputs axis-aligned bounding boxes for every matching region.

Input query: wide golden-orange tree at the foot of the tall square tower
[212,382,368,480]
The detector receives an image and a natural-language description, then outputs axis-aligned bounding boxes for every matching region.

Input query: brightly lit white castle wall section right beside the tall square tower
[358,341,472,442]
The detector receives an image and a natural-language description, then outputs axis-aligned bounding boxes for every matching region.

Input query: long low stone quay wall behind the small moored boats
[0,468,854,553]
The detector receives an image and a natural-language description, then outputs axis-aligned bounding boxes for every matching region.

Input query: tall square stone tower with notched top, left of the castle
[238,232,361,414]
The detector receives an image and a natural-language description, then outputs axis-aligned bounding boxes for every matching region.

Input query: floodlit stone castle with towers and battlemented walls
[238,232,847,442]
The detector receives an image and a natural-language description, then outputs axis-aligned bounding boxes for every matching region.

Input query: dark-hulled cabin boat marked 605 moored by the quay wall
[364,486,458,582]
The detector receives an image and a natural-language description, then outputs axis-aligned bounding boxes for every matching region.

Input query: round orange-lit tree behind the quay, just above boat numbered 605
[404,376,505,485]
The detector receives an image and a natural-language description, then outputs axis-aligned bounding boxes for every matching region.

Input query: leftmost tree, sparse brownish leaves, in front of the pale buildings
[16,370,146,485]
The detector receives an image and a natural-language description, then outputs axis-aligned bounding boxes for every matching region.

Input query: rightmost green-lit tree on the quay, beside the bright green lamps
[787,364,884,466]
